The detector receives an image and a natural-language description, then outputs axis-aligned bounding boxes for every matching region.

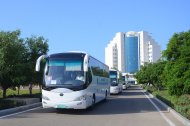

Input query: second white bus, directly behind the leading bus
[109,69,123,94]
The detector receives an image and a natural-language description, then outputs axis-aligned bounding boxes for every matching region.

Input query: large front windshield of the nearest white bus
[44,53,85,88]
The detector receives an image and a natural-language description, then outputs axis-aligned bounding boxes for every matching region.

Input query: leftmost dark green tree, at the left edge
[0,30,25,97]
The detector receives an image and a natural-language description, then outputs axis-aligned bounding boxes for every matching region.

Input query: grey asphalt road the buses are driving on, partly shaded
[0,86,183,126]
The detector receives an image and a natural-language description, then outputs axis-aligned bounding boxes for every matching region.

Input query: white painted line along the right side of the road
[141,90,175,126]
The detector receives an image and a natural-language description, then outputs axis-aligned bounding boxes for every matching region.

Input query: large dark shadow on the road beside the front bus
[54,98,162,115]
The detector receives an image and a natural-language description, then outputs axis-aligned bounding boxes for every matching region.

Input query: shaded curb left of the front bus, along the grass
[0,102,42,117]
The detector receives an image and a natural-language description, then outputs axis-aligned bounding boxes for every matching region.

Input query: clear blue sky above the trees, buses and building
[0,0,190,62]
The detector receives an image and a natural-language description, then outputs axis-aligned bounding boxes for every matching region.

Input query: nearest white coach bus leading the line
[36,52,110,109]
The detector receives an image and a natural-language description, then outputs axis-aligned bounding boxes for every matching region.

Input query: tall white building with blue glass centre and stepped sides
[105,31,161,73]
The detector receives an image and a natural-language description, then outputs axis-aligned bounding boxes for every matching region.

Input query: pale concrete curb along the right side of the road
[145,90,190,126]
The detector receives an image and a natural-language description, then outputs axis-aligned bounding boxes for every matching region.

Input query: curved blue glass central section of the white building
[124,36,139,73]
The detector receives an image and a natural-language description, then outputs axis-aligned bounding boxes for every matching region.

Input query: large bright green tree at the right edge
[163,30,190,95]
